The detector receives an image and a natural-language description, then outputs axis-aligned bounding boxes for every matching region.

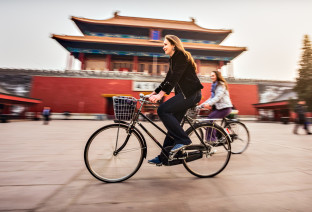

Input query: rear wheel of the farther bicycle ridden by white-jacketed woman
[224,121,250,154]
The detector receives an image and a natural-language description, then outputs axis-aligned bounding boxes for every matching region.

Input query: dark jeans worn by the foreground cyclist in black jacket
[157,91,201,147]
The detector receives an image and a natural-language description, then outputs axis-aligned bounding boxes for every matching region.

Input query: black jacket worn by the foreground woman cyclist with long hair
[155,50,204,98]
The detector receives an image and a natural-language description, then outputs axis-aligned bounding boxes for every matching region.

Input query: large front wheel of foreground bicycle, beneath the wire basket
[84,124,146,183]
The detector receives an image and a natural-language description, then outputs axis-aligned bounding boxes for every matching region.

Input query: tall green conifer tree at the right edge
[294,35,312,111]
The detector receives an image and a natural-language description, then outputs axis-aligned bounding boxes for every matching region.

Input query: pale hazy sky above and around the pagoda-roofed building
[0,0,312,81]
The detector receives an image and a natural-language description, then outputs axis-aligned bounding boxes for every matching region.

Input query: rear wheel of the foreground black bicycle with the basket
[183,123,231,177]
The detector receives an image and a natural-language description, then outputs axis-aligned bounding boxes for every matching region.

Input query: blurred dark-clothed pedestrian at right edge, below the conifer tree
[293,101,312,135]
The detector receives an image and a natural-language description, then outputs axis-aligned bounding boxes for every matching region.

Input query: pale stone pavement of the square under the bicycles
[0,120,312,212]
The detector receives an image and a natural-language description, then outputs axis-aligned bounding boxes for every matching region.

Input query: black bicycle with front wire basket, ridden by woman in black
[84,94,231,183]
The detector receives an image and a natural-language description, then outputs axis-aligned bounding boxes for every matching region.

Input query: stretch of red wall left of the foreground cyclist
[30,76,134,113]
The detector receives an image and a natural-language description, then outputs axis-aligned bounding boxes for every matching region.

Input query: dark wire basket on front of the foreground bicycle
[113,96,137,121]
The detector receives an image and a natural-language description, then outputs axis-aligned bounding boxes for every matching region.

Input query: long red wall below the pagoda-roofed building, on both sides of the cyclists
[31,76,259,115]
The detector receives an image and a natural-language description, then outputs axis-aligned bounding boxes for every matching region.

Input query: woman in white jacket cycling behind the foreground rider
[200,71,233,141]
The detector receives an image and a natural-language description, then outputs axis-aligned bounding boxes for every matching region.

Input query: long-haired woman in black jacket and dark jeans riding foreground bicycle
[148,35,203,165]
